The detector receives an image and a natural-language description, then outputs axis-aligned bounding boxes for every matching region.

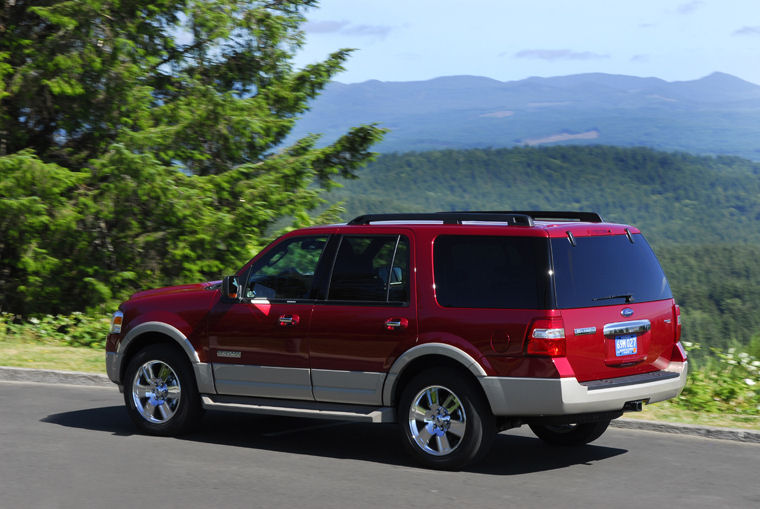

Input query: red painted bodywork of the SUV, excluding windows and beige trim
[106,222,684,381]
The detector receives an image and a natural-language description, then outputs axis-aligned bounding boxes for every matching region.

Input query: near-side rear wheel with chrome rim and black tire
[397,369,496,470]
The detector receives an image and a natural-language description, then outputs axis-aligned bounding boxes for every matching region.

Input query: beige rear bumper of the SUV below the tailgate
[479,362,688,416]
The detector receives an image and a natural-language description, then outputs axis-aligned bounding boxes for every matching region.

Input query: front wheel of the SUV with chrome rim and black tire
[124,345,203,436]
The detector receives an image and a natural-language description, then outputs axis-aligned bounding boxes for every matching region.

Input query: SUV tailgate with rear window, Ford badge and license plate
[552,234,676,381]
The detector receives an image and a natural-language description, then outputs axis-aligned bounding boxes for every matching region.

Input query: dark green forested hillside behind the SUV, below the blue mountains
[331,146,760,346]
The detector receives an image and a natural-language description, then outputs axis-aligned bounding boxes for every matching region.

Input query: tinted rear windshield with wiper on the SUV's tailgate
[551,234,673,309]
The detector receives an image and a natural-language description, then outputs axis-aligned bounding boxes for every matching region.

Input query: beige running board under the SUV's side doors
[201,394,396,423]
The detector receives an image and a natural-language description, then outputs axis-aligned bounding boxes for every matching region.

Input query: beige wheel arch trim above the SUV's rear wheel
[383,343,486,406]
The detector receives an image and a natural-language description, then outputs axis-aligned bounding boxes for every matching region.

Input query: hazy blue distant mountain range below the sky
[290,73,760,160]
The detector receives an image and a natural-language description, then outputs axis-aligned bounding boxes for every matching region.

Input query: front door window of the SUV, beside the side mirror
[245,236,327,299]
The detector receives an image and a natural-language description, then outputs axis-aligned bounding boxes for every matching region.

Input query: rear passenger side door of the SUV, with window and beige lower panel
[309,227,417,405]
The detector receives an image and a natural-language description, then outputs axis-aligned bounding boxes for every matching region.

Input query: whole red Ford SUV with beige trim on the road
[106,212,687,469]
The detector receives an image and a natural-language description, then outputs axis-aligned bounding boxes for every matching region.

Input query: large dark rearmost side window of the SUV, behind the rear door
[433,235,551,309]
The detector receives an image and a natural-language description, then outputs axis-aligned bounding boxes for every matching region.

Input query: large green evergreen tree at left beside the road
[0,0,382,313]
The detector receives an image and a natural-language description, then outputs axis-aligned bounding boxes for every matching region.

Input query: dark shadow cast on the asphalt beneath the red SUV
[42,406,628,475]
